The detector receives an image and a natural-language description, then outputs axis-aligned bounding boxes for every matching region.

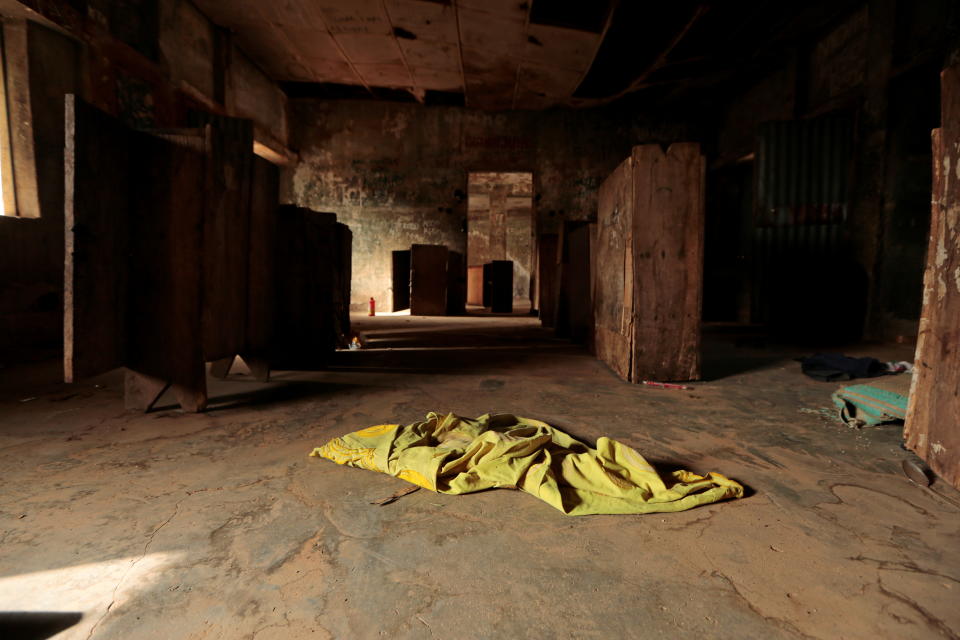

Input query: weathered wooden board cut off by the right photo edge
[904,65,960,489]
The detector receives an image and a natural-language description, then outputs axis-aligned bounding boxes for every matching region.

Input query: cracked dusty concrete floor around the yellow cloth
[0,316,960,639]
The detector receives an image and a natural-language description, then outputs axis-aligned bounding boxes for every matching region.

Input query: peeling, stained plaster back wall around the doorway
[283,99,689,309]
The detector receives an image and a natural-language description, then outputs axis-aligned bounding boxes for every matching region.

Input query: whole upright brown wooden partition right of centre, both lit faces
[593,143,704,382]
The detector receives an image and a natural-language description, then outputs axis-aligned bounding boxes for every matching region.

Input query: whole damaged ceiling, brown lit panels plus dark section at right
[195,0,864,110]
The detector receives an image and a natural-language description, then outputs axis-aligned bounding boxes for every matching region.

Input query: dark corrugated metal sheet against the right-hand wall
[752,115,853,322]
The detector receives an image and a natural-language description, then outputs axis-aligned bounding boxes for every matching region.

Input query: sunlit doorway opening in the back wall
[467,171,536,312]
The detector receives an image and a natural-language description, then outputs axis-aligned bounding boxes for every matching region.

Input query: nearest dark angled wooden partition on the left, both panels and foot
[64,95,209,410]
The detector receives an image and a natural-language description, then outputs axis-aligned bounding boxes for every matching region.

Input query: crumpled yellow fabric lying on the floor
[310,413,743,516]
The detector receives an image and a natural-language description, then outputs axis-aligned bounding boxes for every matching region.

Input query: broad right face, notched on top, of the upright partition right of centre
[631,143,705,382]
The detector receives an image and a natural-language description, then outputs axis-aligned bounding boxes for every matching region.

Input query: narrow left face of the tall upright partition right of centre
[594,158,634,380]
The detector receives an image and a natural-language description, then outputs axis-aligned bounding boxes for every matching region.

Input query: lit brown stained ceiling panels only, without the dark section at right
[197,0,610,109]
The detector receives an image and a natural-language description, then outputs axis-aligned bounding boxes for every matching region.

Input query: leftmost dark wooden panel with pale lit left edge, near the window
[63,95,133,382]
